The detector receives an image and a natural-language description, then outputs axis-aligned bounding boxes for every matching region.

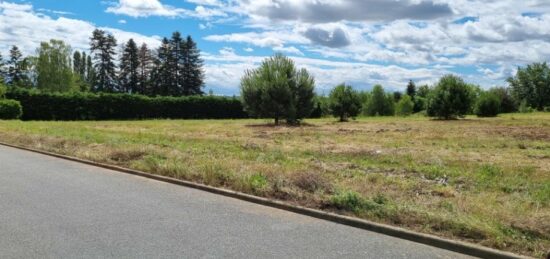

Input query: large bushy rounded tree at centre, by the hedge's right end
[241,54,315,125]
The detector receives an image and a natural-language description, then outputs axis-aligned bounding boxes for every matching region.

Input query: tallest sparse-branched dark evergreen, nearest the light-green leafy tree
[90,29,118,92]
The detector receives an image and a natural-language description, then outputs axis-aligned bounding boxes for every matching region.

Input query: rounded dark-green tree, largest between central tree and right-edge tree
[427,75,472,119]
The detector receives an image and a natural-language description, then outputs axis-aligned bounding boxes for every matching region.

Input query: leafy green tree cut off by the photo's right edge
[508,63,550,111]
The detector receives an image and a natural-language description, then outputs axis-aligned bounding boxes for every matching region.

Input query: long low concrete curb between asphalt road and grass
[0,142,529,259]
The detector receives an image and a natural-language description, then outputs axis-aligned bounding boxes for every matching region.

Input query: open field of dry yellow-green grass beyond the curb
[0,113,550,257]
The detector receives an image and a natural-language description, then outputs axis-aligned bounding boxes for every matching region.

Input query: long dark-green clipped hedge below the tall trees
[6,89,248,120]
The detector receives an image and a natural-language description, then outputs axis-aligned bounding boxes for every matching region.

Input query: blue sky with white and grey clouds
[0,0,550,95]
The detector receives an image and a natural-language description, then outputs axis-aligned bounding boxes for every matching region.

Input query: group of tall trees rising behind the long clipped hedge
[0,29,204,96]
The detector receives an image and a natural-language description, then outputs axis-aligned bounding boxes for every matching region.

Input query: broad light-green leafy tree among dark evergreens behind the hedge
[35,40,76,92]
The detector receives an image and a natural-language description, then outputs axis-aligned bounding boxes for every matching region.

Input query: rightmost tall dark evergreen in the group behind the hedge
[183,36,204,95]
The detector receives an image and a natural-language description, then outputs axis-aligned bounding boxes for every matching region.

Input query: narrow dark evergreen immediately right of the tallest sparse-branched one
[119,39,139,93]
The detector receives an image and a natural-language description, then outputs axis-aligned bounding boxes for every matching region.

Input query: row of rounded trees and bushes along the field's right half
[241,54,550,124]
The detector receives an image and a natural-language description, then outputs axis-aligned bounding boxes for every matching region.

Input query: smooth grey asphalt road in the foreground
[0,146,474,258]
